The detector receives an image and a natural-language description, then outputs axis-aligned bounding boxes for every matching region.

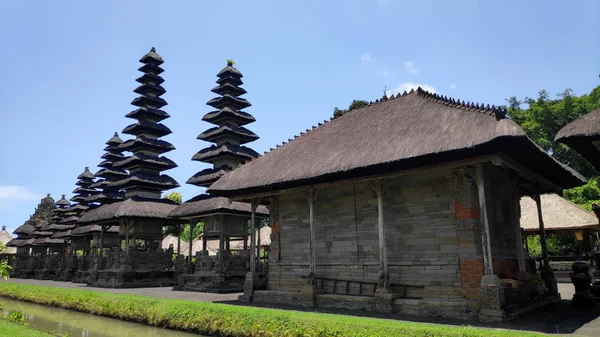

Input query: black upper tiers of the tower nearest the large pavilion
[187,61,258,187]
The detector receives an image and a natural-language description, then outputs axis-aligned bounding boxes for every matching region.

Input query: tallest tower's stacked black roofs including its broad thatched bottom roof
[79,48,179,224]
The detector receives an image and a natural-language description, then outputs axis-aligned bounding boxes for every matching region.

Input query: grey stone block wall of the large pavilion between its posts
[269,169,462,298]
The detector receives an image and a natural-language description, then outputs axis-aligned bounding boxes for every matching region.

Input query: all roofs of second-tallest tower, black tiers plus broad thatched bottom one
[170,61,268,219]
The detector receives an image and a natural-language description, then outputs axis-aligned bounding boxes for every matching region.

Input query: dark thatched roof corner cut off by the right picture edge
[554,109,600,171]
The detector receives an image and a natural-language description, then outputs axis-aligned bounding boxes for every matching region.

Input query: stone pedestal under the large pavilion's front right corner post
[479,275,505,322]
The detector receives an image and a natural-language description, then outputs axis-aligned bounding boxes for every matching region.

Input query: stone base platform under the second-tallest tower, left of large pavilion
[173,272,246,294]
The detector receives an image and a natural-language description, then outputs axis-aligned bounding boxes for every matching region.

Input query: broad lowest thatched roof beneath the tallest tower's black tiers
[79,197,179,223]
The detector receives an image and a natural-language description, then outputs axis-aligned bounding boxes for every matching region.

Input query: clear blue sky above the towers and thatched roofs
[0,0,600,231]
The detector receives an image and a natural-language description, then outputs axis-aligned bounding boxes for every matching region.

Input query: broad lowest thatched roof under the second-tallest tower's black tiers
[169,194,269,219]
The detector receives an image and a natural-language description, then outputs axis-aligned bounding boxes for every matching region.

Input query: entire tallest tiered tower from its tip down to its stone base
[79,48,179,288]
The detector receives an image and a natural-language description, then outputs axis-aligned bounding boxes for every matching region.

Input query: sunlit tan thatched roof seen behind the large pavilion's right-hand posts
[521,194,600,232]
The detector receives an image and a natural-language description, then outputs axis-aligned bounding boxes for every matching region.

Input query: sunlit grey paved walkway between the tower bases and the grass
[1,278,240,302]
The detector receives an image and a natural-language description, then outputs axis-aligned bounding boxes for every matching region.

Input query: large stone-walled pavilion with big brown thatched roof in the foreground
[208,88,585,321]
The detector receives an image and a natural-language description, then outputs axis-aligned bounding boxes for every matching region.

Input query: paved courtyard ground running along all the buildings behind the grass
[0,279,600,336]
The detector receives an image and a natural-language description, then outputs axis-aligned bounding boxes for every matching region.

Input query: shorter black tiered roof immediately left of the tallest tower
[86,132,128,205]
